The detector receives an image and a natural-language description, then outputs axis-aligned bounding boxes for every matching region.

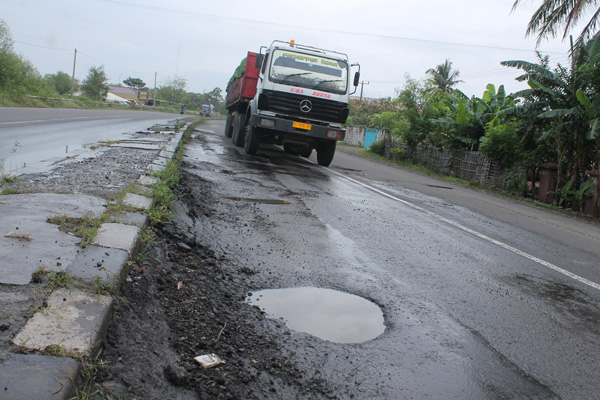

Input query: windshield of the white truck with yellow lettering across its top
[269,49,348,94]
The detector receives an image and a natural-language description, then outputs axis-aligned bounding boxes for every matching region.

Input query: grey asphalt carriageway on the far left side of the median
[0,108,179,174]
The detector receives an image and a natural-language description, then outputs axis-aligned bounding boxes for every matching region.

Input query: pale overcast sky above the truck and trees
[0,0,579,98]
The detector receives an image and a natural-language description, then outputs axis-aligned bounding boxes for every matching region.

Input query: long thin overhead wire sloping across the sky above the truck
[96,0,563,54]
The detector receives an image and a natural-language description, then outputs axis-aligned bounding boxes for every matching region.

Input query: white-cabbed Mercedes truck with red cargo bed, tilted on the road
[225,40,360,166]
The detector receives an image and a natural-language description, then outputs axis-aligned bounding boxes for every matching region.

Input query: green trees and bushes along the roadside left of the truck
[0,19,225,115]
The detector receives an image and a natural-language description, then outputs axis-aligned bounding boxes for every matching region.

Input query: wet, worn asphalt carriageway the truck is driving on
[184,121,600,399]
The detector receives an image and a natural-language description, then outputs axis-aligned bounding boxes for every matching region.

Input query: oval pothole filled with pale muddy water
[248,287,385,343]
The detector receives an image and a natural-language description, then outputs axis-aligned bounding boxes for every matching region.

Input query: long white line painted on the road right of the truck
[326,164,600,290]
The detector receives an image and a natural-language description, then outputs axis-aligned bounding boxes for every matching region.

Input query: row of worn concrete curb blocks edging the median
[0,123,189,400]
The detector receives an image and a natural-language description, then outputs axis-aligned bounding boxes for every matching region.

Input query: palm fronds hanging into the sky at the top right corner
[513,0,600,47]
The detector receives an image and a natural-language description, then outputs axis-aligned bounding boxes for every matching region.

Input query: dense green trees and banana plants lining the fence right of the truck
[348,18,600,217]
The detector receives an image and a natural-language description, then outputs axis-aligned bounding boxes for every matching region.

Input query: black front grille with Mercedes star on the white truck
[259,90,348,124]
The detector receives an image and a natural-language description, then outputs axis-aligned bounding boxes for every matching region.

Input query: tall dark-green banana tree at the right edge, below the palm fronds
[501,38,600,206]
